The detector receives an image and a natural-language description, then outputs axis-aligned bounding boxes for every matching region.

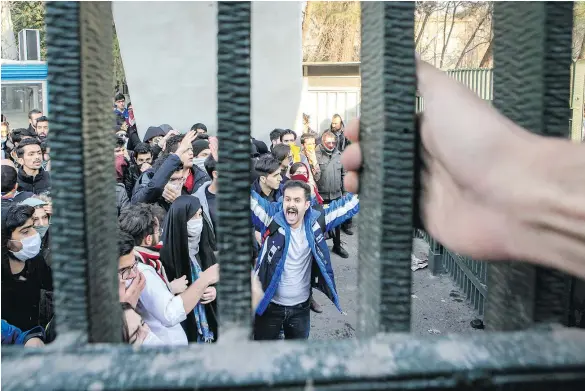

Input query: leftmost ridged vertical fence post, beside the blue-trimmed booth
[46,1,122,343]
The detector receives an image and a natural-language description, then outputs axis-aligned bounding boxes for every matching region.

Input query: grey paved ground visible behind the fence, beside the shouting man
[310,229,481,339]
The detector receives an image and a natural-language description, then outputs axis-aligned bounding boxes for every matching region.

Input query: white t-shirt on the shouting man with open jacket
[272,224,313,306]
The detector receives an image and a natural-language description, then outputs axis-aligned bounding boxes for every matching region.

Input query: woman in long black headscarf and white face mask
[160,195,217,342]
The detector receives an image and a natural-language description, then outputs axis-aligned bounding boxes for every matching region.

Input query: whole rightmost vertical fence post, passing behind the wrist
[486,2,573,330]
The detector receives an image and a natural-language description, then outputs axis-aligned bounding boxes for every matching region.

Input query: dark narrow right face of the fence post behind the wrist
[534,1,574,324]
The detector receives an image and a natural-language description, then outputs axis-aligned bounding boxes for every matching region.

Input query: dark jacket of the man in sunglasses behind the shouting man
[314,145,345,201]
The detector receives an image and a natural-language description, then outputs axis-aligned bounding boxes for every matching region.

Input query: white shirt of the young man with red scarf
[136,263,189,345]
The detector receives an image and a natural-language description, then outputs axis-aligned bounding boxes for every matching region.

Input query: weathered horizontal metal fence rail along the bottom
[2,329,585,391]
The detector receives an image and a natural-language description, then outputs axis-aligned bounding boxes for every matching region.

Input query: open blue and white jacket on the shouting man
[250,191,359,315]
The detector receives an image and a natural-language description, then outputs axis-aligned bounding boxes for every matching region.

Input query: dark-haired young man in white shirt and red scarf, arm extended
[119,205,219,345]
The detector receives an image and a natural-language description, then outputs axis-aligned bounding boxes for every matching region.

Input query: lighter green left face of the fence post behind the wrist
[485,2,547,330]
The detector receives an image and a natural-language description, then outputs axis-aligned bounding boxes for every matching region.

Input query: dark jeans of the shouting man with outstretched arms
[254,298,311,341]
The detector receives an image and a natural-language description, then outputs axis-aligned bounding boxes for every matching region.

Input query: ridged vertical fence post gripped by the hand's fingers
[358,2,416,335]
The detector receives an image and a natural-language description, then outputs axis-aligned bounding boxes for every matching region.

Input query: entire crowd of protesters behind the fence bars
[1,94,359,346]
